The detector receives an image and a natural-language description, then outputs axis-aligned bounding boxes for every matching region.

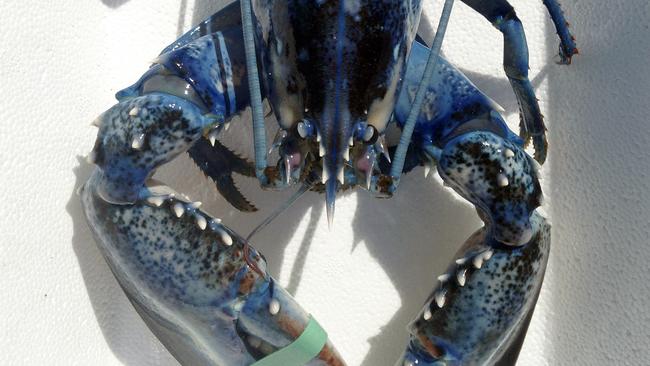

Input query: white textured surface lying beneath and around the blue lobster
[0,0,650,366]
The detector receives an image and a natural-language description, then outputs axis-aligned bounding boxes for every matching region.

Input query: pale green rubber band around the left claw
[251,317,327,366]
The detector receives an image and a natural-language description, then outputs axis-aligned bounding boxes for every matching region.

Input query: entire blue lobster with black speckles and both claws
[81,0,577,366]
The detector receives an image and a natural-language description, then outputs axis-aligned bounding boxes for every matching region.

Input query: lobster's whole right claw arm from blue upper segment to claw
[396,38,550,365]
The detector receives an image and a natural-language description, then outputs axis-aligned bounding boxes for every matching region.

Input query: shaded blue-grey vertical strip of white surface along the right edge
[546,0,650,365]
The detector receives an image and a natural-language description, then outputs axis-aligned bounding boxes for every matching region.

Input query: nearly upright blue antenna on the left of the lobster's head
[241,0,267,183]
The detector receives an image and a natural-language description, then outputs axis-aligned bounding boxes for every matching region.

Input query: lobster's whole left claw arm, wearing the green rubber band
[81,24,343,366]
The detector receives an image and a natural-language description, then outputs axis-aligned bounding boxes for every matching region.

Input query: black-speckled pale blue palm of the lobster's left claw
[85,179,264,306]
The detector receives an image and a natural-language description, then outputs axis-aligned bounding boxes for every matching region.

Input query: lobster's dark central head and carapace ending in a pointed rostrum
[253,0,420,225]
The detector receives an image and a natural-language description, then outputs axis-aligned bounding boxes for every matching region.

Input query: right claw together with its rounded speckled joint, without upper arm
[404,131,550,365]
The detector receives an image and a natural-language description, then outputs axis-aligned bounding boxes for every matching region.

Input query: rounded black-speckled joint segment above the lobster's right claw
[439,132,541,244]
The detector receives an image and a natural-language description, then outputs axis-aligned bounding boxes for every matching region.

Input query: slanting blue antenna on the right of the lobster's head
[390,0,454,182]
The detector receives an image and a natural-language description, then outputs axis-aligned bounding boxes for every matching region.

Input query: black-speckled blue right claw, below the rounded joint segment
[411,213,550,364]
